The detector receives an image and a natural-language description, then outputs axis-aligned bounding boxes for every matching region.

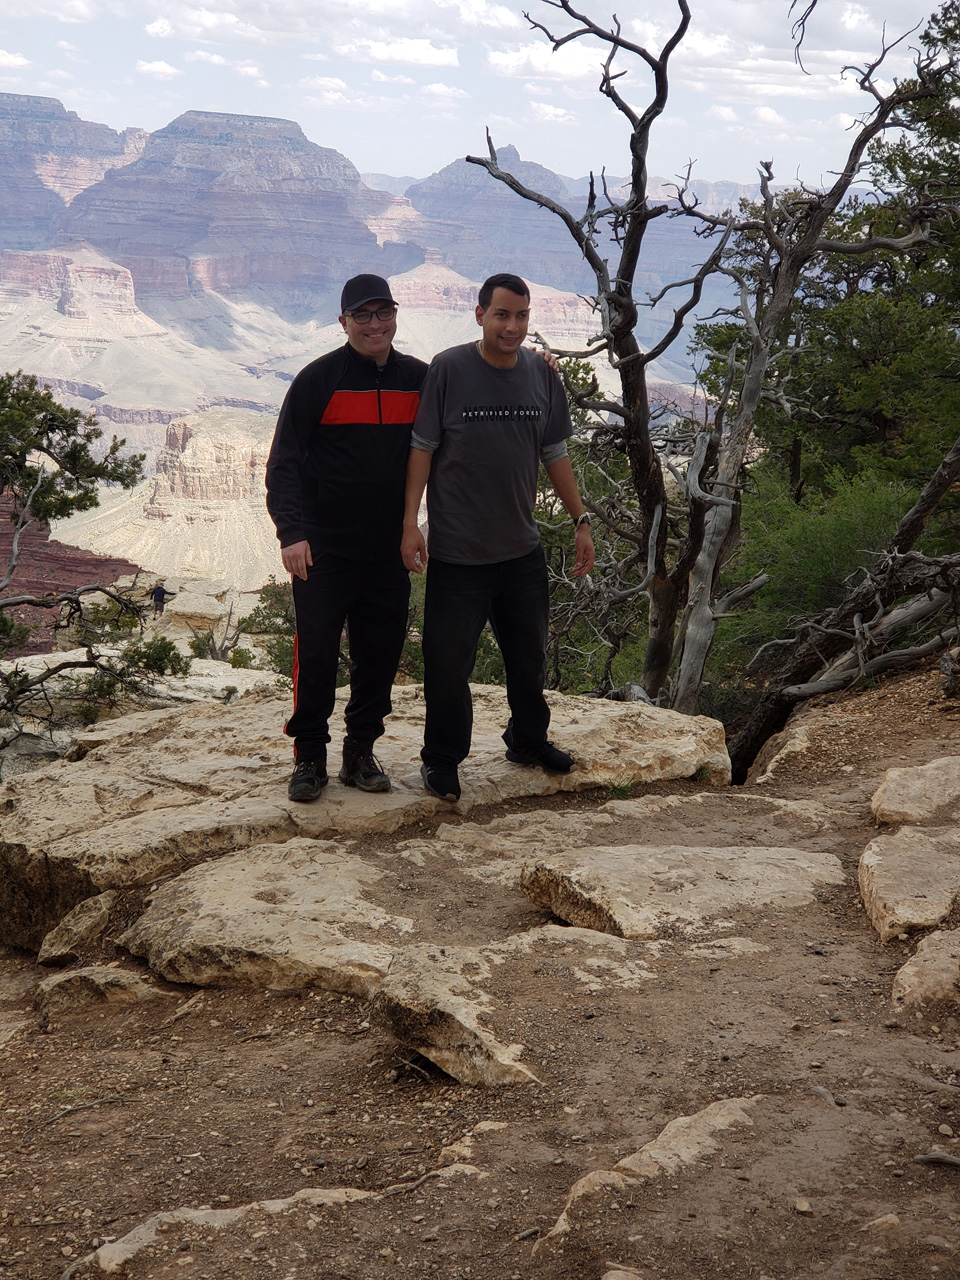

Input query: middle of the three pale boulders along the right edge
[858,827,960,942]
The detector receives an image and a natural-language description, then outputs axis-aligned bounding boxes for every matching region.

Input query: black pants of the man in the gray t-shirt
[420,547,550,764]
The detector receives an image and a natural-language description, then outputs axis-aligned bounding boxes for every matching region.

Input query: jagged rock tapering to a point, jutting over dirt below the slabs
[370,946,539,1084]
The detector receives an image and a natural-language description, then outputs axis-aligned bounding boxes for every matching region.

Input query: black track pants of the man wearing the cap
[283,549,410,760]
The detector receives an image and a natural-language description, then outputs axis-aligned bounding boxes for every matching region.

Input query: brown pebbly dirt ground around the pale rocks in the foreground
[0,667,960,1280]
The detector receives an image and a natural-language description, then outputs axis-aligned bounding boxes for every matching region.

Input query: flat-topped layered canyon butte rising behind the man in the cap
[63,111,422,303]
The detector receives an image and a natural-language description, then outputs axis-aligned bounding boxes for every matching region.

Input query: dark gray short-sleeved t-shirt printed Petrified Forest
[412,342,573,564]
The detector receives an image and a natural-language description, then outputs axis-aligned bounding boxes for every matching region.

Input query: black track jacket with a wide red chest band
[266,343,426,559]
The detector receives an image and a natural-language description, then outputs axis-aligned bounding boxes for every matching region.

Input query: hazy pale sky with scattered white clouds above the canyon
[0,0,933,183]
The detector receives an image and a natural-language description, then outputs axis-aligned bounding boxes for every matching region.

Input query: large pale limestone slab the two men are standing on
[0,686,730,948]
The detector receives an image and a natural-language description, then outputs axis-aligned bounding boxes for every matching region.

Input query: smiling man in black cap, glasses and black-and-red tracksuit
[266,275,426,800]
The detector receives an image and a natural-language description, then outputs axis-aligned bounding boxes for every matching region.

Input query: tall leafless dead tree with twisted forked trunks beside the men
[467,0,948,713]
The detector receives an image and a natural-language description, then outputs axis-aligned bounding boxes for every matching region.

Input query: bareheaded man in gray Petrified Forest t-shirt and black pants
[401,274,594,800]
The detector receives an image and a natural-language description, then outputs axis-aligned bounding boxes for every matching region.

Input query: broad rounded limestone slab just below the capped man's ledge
[120,838,412,997]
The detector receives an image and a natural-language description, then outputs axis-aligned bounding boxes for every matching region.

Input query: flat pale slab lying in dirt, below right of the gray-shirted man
[520,845,845,938]
